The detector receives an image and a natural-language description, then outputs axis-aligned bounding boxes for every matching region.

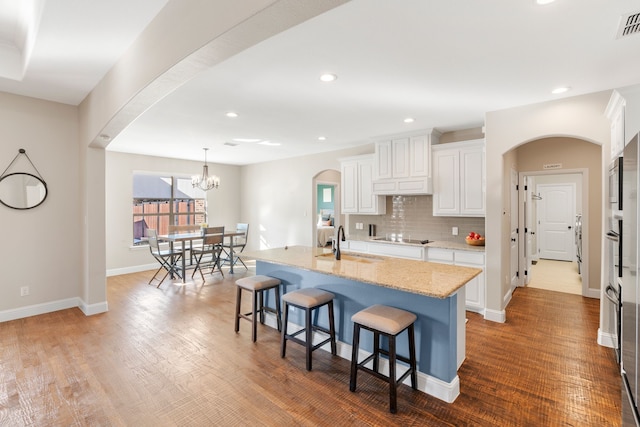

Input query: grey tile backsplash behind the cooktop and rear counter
[347,196,485,243]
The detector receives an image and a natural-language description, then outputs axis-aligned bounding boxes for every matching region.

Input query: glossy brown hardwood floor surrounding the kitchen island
[0,268,621,427]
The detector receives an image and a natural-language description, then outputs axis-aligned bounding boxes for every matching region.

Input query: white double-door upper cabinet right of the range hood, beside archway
[433,139,486,217]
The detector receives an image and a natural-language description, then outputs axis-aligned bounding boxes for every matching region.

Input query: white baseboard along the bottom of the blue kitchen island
[264,313,460,403]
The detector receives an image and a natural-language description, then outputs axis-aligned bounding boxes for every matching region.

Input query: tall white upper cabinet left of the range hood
[340,154,387,215]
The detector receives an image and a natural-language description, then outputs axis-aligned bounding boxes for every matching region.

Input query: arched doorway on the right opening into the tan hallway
[510,137,603,298]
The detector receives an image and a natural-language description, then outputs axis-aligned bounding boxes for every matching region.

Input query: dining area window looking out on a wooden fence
[133,173,207,245]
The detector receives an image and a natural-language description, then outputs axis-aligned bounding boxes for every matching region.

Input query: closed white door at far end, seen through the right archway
[536,183,576,261]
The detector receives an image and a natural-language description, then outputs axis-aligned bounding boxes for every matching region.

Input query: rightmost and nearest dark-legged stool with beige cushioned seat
[349,304,418,414]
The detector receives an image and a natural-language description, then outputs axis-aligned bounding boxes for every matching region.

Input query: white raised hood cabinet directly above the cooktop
[373,130,440,195]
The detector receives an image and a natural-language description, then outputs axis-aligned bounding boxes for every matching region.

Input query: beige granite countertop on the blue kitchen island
[241,246,482,298]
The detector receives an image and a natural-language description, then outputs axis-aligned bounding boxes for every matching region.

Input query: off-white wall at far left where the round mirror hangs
[0,93,83,321]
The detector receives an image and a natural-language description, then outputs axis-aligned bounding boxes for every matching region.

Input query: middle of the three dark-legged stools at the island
[280,288,336,371]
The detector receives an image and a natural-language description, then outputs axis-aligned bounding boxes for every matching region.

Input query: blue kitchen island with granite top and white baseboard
[243,246,481,402]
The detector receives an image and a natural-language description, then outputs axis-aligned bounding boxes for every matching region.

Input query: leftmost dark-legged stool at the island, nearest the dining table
[235,275,282,342]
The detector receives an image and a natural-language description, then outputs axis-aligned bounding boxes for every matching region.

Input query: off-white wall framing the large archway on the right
[485,91,611,321]
